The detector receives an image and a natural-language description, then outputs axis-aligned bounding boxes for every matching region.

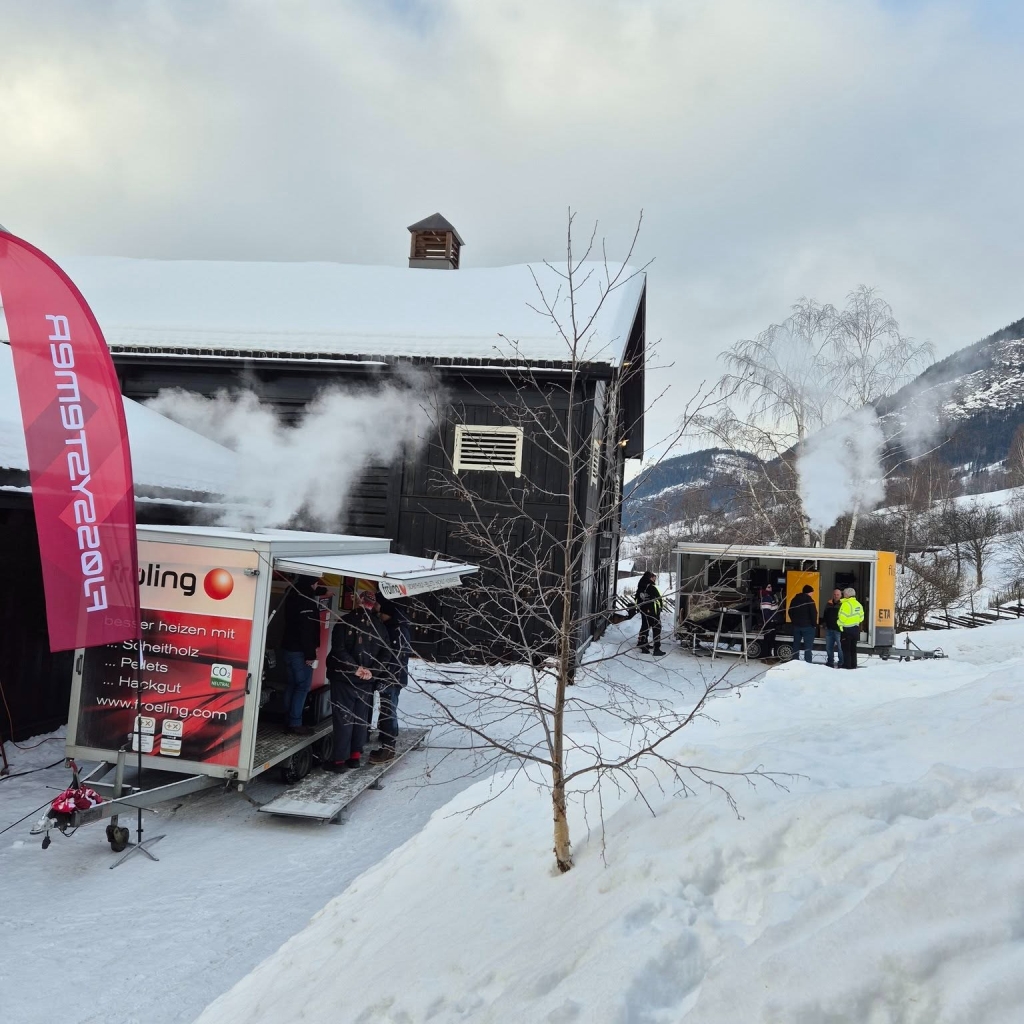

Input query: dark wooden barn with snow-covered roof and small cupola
[22,214,645,657]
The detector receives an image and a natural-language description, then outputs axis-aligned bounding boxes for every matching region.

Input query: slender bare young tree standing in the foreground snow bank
[407,214,782,871]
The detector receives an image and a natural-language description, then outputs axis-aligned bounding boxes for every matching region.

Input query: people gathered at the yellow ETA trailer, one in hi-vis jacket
[760,584,864,669]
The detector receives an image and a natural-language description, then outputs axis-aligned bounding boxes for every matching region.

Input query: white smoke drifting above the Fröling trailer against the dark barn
[146,374,438,529]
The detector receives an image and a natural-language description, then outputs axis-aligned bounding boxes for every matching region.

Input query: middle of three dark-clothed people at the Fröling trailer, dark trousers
[324,590,390,772]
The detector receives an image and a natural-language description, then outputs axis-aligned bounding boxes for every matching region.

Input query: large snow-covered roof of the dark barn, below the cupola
[0,258,646,366]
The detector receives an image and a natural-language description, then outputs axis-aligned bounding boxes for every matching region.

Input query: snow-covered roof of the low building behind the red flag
[0,345,238,495]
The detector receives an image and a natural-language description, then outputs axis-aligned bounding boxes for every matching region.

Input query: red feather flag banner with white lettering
[0,229,140,651]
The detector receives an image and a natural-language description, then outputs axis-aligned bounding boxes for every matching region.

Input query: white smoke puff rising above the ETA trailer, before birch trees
[797,406,885,532]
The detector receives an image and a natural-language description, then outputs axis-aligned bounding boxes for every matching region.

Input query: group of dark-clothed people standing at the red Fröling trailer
[282,577,413,772]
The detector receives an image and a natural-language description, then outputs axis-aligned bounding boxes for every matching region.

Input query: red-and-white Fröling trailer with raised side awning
[51,526,477,849]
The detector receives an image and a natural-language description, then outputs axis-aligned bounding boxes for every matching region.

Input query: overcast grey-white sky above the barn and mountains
[0,0,1024,456]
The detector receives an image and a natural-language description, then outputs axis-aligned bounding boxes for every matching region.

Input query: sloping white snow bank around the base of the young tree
[200,623,1024,1024]
